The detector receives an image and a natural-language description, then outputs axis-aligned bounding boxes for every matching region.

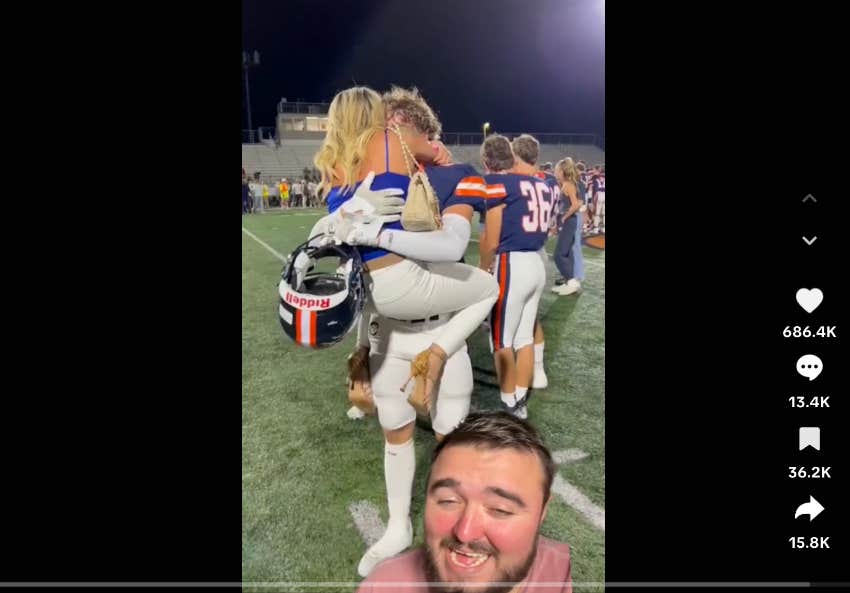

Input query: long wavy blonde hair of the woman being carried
[313,86,386,193]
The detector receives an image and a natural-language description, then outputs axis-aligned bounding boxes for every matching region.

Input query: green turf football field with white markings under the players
[242,210,605,592]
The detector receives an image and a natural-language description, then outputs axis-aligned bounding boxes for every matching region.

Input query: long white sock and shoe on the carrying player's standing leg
[357,439,416,577]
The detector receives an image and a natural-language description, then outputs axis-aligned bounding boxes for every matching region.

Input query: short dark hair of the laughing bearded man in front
[431,411,555,504]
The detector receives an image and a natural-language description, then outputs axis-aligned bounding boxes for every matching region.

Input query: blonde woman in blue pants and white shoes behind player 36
[552,157,581,296]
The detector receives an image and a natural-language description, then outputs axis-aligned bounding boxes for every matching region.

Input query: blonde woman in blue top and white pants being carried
[315,87,498,410]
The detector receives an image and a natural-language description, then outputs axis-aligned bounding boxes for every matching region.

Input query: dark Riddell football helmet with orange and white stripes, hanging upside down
[278,241,365,348]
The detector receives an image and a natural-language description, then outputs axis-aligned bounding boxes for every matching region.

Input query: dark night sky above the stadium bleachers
[240,0,605,135]
